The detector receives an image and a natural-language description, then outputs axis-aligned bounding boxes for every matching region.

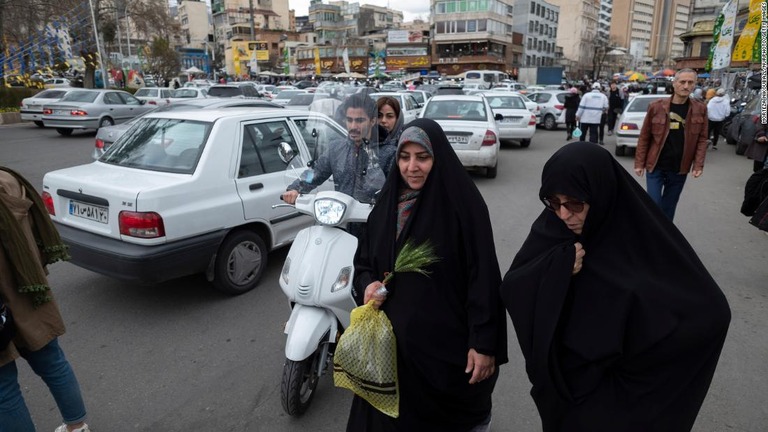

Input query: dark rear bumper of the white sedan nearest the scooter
[54,222,226,283]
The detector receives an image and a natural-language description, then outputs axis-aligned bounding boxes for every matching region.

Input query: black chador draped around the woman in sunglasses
[501,143,730,432]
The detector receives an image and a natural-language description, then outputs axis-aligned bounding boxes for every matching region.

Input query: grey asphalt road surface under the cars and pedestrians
[0,124,768,432]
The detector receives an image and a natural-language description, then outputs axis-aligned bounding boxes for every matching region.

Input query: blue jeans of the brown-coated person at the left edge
[0,339,85,432]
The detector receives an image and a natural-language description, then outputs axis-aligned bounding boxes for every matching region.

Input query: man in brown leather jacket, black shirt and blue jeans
[635,69,708,220]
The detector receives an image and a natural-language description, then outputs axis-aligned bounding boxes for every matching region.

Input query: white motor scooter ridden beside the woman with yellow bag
[279,143,382,416]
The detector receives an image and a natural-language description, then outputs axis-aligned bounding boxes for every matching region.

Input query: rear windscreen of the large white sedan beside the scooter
[99,118,212,174]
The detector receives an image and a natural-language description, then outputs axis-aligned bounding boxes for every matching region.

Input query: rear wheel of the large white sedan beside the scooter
[213,230,267,295]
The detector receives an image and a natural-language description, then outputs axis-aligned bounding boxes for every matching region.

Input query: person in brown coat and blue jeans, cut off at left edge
[0,167,89,432]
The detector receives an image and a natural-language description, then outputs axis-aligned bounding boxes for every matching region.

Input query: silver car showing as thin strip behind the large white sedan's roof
[92,98,282,159]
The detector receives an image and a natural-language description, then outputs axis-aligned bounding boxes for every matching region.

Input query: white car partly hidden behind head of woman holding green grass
[420,95,501,178]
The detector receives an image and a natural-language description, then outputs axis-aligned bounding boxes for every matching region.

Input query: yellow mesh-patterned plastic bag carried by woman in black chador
[333,303,400,417]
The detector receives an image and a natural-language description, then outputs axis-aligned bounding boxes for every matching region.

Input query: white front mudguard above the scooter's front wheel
[285,304,338,361]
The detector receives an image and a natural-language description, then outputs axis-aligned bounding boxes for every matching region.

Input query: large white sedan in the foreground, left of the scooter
[42,108,346,294]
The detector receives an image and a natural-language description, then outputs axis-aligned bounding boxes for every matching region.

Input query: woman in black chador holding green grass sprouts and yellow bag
[347,119,507,432]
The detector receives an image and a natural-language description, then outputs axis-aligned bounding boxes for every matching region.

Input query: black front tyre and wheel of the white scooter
[280,350,320,417]
